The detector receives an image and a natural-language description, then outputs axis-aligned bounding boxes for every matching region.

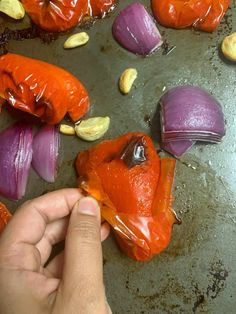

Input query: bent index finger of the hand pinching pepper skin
[1,189,82,245]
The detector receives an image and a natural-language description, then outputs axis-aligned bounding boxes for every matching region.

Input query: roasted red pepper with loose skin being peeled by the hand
[76,133,177,261]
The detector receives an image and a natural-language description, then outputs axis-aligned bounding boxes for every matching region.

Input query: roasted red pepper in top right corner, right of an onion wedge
[151,0,230,32]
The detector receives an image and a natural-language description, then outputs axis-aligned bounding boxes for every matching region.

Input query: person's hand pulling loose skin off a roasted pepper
[0,189,111,314]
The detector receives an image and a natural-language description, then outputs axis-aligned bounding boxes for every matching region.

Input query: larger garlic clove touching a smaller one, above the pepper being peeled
[75,117,110,142]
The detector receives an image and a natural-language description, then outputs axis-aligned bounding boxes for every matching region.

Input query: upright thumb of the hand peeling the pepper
[63,197,105,313]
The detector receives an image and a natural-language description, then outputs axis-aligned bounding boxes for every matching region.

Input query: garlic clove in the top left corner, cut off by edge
[0,0,25,20]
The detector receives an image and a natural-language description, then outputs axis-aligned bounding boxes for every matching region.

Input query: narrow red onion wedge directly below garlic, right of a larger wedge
[32,125,60,182]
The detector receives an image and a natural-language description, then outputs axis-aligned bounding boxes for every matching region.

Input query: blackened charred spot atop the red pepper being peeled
[120,137,147,169]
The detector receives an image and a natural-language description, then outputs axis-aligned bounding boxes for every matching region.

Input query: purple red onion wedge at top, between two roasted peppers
[112,2,163,56]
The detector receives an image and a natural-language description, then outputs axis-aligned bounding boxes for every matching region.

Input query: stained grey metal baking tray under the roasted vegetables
[0,1,236,314]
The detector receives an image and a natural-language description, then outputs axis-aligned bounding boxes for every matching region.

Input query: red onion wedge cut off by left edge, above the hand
[0,122,33,200]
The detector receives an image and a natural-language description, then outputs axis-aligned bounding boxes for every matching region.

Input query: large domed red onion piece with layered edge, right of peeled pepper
[160,85,225,157]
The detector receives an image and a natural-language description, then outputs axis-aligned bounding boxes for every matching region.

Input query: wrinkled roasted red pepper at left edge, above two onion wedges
[0,53,89,124]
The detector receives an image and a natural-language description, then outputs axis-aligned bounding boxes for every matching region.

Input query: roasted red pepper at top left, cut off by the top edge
[21,0,116,32]
